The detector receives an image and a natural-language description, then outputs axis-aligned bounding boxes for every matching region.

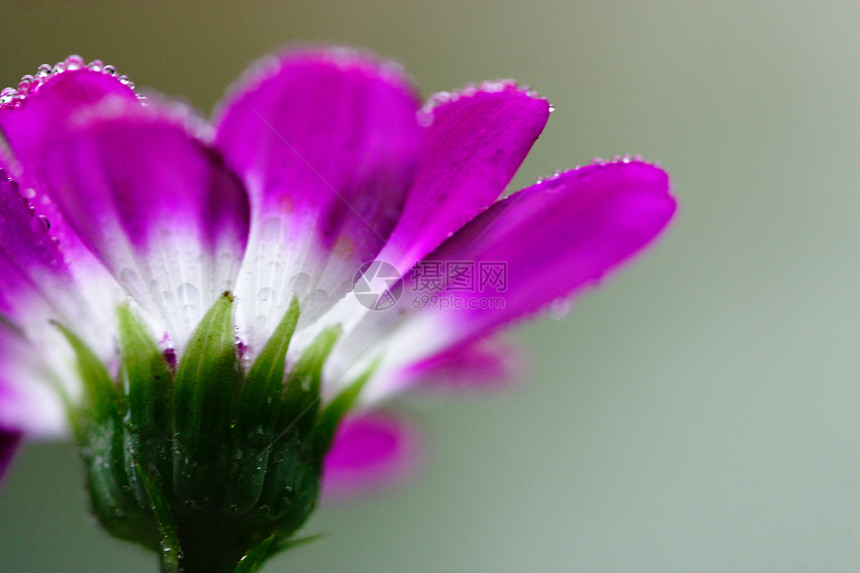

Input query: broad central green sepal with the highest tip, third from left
[173,293,241,502]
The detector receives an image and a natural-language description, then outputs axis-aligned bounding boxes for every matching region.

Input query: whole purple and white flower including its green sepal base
[0,48,675,570]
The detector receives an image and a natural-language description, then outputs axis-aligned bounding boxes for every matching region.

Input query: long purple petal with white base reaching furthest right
[336,160,675,401]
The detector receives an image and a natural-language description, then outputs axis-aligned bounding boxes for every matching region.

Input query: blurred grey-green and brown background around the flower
[0,0,860,573]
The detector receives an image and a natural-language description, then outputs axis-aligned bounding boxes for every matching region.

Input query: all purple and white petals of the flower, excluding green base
[0,49,675,500]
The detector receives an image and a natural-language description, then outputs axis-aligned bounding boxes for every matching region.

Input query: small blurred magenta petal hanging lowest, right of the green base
[323,413,419,499]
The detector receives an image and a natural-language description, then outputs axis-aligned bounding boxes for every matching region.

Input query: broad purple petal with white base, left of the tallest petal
[45,100,249,348]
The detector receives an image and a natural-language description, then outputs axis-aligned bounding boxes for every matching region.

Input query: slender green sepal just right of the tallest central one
[224,297,299,514]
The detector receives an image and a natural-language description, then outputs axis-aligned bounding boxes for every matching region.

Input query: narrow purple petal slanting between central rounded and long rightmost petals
[378,82,549,274]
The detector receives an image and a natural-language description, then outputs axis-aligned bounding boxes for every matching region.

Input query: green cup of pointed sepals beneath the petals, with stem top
[58,293,369,573]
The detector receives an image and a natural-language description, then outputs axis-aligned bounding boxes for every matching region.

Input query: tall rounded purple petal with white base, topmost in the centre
[217,50,421,351]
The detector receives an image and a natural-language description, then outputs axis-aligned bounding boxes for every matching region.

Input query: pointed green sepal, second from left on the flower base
[117,305,173,503]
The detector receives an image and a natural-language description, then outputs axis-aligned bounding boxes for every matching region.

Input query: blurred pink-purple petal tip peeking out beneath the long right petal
[395,332,524,392]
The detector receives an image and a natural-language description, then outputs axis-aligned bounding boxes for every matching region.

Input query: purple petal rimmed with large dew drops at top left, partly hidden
[0,60,137,258]
